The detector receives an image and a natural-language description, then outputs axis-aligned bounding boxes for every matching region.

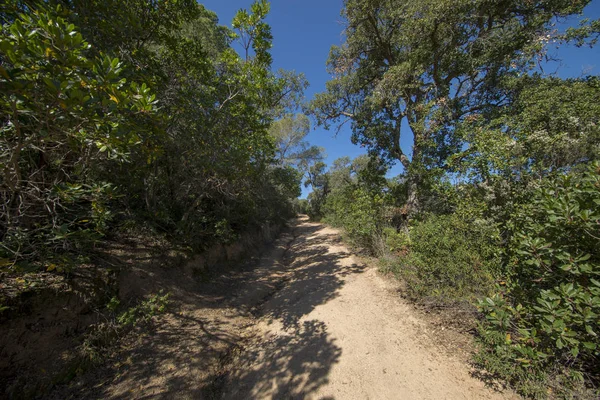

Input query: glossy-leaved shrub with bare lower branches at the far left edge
[0,3,155,262]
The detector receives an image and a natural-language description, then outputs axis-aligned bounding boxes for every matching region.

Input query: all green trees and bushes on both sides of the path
[0,0,600,398]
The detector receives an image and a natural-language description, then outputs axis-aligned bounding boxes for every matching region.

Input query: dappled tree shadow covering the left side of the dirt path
[53,217,365,399]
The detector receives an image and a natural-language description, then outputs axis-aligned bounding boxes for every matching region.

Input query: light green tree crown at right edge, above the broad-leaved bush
[450,76,600,181]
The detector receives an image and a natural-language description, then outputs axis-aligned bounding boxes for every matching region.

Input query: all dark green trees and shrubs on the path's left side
[0,0,310,271]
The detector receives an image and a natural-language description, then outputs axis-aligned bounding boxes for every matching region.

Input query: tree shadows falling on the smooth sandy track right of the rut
[222,221,365,399]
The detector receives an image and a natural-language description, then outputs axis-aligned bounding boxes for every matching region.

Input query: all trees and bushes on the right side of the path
[306,0,600,398]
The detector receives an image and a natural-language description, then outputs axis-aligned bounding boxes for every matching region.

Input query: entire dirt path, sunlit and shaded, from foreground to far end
[43,218,517,399]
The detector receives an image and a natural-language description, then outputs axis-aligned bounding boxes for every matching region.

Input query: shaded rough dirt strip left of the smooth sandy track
[41,223,294,399]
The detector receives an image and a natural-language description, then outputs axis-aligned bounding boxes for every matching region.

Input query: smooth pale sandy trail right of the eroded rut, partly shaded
[221,219,514,399]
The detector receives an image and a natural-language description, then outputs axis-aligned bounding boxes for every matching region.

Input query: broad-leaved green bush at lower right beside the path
[478,164,600,398]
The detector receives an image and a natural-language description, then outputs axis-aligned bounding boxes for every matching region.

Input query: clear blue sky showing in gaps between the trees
[199,0,600,197]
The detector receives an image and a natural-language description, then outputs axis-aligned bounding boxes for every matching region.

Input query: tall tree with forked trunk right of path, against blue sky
[311,0,589,214]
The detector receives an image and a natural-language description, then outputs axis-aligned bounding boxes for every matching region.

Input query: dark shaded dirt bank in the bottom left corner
[0,265,115,399]
